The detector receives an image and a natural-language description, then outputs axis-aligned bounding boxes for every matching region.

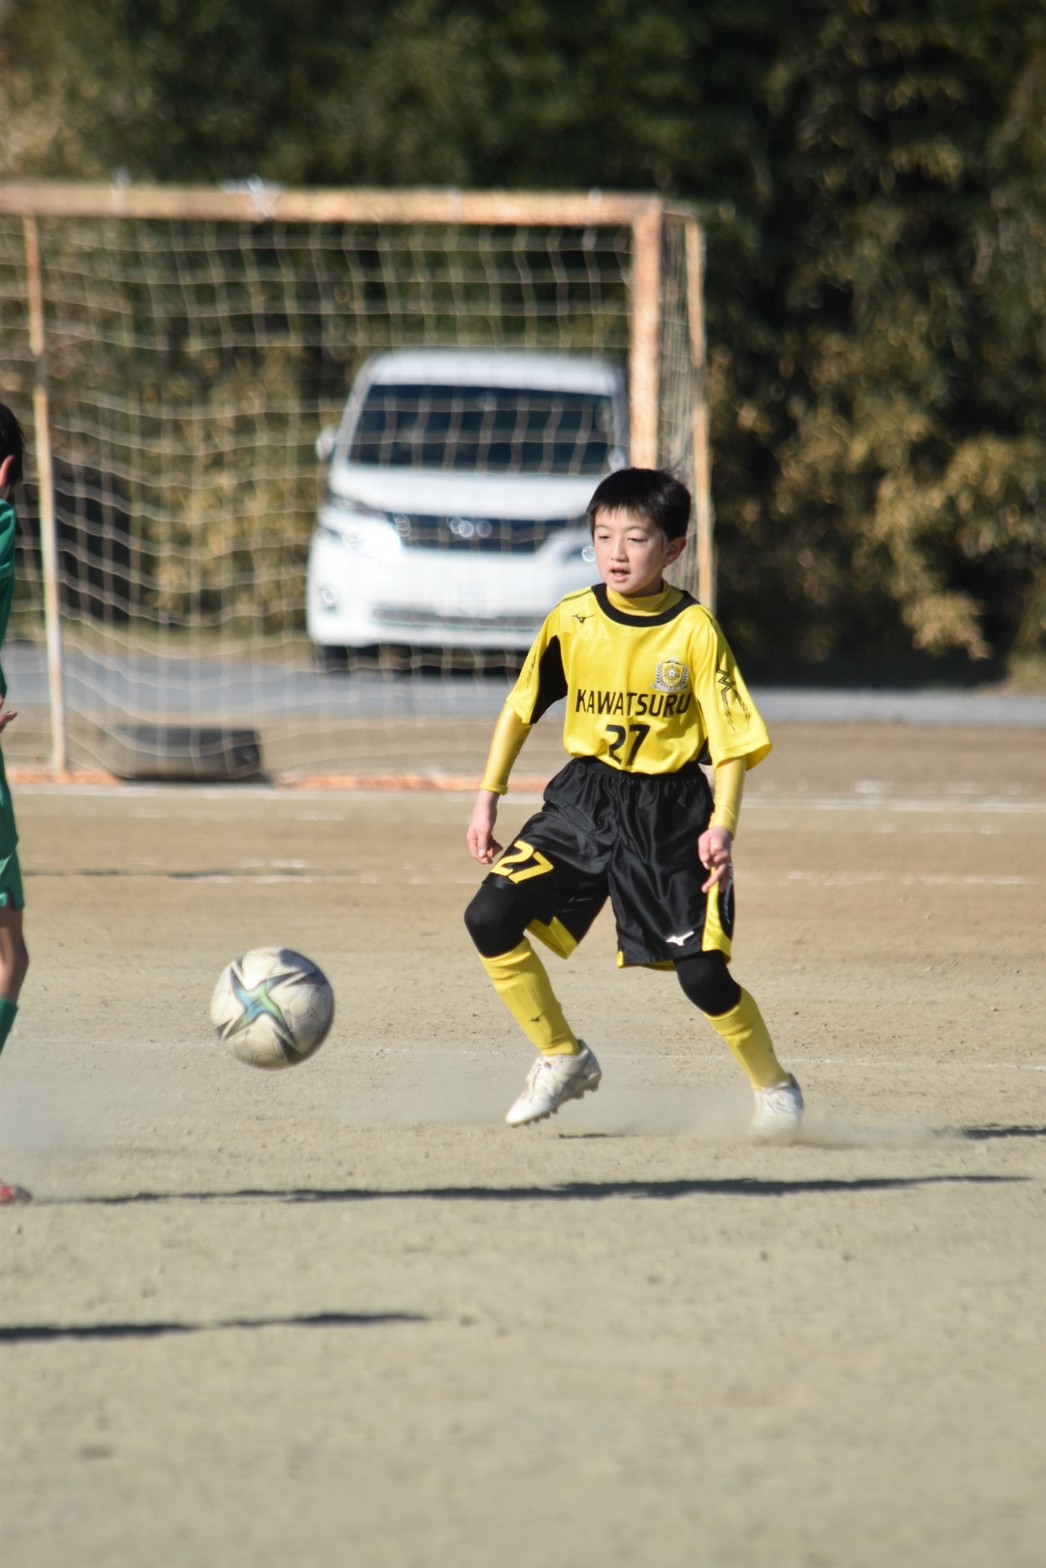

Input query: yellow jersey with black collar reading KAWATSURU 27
[508,583,770,773]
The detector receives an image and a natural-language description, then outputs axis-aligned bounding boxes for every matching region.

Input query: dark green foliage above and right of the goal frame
[0,0,1046,663]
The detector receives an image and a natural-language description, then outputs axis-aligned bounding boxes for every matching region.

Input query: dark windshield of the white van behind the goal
[348,384,616,477]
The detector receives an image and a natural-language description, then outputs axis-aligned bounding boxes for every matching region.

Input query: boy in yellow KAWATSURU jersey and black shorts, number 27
[466,469,803,1140]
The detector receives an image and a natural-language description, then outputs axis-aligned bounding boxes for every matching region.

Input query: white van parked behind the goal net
[306,348,627,668]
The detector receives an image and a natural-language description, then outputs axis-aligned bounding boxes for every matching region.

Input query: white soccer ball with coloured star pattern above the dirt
[210,947,334,1068]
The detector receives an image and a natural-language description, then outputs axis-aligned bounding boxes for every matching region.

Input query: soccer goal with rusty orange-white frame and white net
[0,183,714,782]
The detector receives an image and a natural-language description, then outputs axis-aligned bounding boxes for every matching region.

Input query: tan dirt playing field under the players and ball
[0,726,1046,1568]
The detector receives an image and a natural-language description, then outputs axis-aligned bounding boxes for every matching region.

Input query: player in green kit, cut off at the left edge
[0,403,30,1204]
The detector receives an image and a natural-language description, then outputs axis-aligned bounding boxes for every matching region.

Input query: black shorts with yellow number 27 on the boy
[488,757,734,966]
